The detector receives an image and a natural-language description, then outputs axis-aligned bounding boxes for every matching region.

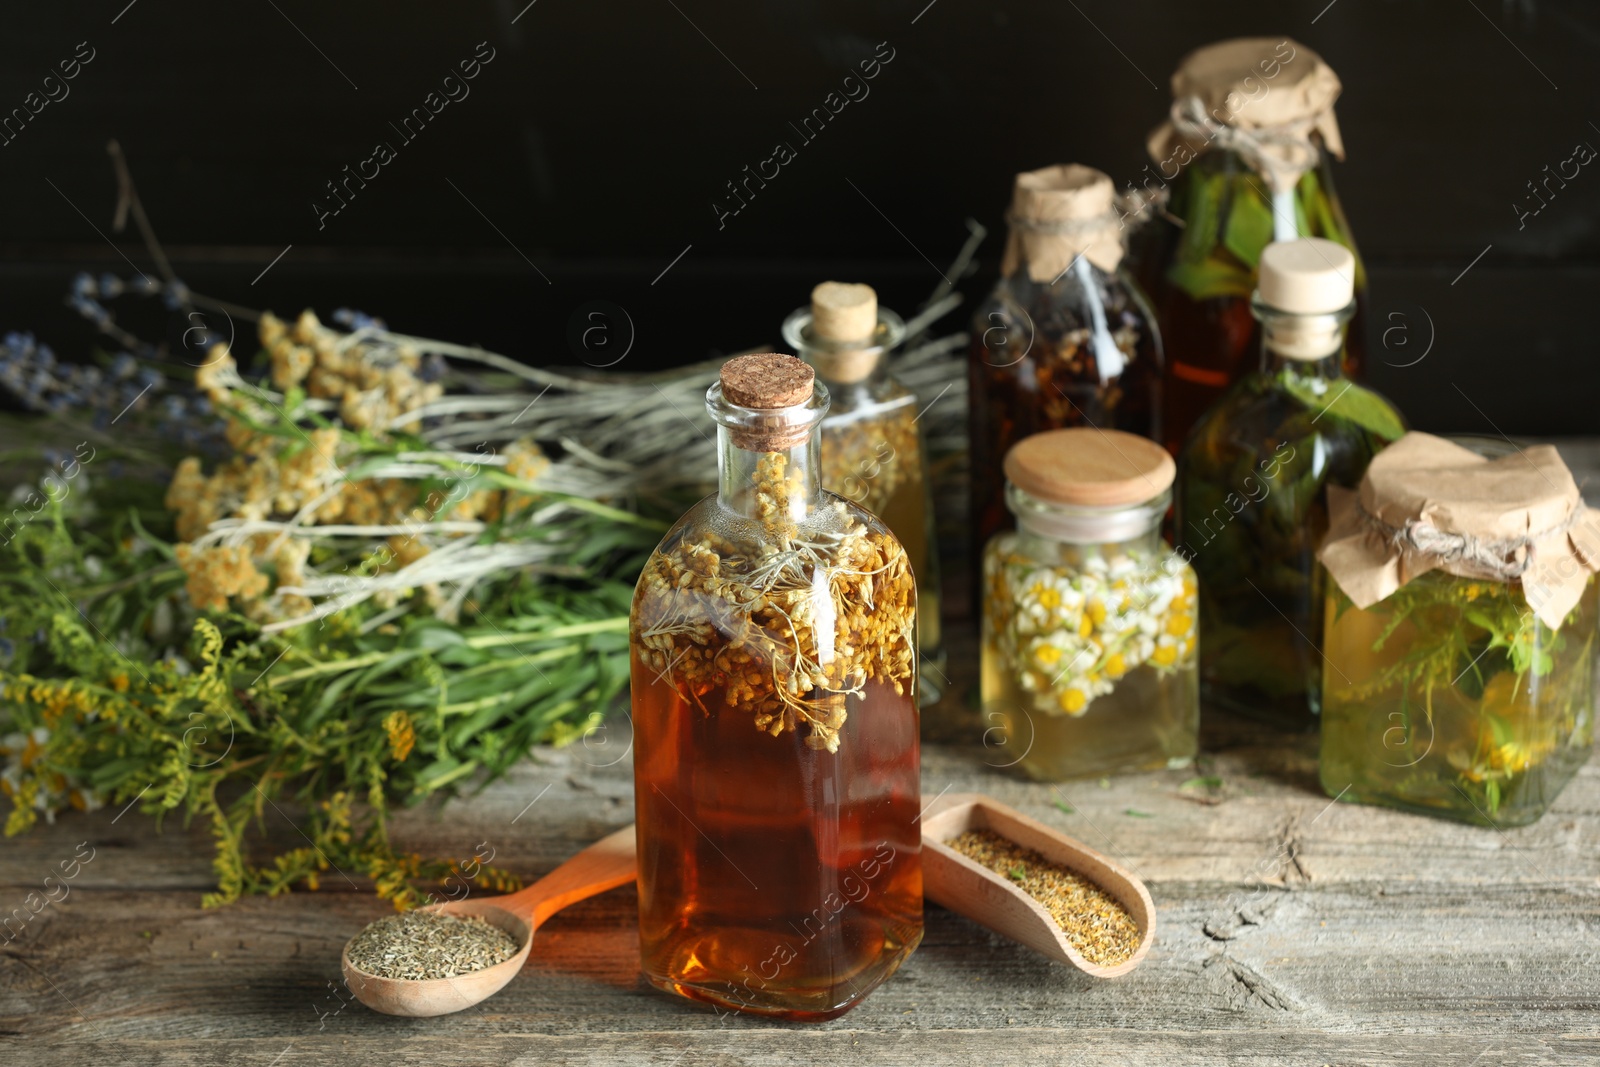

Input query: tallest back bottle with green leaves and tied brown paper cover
[1136,37,1366,454]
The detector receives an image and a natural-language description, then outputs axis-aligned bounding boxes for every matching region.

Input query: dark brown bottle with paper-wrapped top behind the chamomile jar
[968,163,1162,588]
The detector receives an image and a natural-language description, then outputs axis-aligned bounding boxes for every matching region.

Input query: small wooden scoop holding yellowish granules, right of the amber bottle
[922,793,1155,977]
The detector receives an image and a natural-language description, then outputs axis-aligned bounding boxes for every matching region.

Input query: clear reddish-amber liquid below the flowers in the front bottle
[634,656,922,1021]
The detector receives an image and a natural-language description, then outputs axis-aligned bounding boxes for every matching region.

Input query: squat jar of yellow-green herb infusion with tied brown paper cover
[1318,434,1600,827]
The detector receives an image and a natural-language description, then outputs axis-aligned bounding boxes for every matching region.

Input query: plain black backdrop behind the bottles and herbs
[0,0,1600,435]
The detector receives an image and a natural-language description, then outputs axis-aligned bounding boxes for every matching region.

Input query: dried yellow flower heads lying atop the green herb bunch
[166,312,550,619]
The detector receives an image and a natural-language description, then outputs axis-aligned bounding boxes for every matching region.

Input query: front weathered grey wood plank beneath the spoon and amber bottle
[0,883,1600,1041]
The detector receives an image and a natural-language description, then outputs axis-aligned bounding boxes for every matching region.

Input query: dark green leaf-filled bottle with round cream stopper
[1176,237,1405,729]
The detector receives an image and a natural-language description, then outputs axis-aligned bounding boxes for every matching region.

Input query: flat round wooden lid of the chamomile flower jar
[1005,427,1178,507]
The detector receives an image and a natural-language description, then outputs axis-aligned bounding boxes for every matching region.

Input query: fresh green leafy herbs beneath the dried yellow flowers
[0,451,646,905]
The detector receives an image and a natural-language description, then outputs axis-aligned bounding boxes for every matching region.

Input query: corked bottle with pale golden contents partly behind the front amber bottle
[784,282,944,705]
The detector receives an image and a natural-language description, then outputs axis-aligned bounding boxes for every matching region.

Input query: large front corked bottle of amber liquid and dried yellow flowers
[630,355,922,1021]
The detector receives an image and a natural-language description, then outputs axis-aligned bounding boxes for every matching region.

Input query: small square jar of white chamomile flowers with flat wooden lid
[982,429,1200,781]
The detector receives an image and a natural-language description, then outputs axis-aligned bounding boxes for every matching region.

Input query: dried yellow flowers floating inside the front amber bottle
[632,453,917,752]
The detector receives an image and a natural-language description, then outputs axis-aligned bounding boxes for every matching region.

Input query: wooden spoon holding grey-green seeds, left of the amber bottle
[341,825,637,1017]
